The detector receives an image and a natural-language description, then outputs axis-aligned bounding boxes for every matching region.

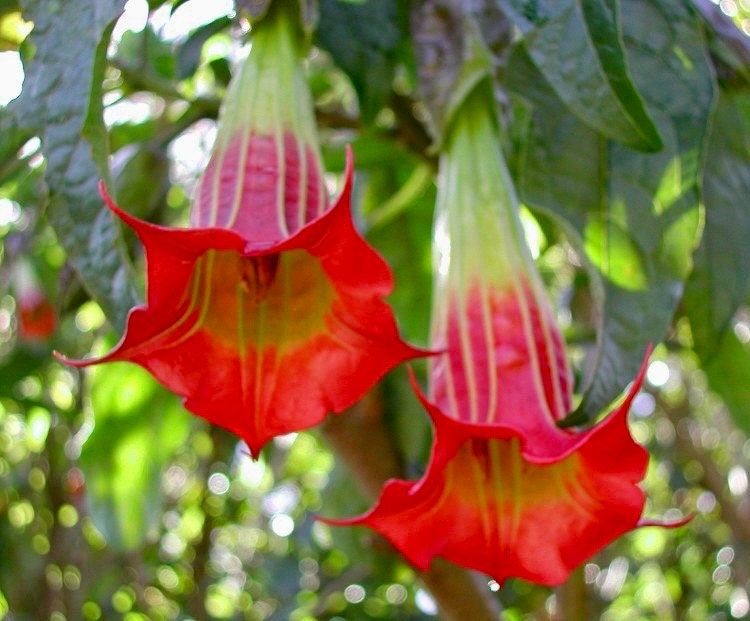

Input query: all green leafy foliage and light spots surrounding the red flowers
[0,0,750,621]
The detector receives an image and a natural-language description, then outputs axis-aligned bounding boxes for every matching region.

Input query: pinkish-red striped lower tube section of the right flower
[430,274,572,437]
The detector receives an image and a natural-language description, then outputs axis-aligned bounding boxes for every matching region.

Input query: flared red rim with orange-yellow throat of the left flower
[57,148,423,455]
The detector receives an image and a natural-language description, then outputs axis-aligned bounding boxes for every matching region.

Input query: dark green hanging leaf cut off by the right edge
[684,92,750,361]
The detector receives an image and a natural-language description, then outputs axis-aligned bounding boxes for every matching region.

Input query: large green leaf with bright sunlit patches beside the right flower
[509,0,714,424]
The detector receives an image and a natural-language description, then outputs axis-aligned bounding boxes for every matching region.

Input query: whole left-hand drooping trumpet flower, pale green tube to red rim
[57,2,421,455]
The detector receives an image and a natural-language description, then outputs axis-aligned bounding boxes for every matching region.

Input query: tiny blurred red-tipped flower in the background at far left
[12,259,57,342]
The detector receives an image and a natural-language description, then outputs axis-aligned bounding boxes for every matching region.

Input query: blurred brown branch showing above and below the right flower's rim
[323,388,501,621]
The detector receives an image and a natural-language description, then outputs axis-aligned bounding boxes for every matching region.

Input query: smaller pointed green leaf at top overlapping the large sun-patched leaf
[500,0,662,151]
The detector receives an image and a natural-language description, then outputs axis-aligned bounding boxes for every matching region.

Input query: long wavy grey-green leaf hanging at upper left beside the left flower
[14,0,137,327]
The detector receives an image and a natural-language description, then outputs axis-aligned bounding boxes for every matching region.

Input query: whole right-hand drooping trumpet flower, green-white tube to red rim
[332,87,676,585]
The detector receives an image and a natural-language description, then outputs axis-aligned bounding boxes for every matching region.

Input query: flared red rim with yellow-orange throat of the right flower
[330,358,648,585]
